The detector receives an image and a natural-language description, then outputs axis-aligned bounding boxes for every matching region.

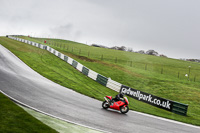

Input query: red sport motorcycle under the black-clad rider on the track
[102,96,129,114]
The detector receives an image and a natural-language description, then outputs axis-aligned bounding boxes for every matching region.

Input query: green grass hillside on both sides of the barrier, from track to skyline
[0,37,200,125]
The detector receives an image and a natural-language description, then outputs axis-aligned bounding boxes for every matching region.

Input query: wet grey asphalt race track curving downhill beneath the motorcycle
[0,45,200,133]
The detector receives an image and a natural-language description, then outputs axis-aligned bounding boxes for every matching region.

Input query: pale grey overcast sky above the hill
[0,0,200,59]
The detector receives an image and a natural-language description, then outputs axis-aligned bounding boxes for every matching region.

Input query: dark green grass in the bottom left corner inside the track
[0,93,56,133]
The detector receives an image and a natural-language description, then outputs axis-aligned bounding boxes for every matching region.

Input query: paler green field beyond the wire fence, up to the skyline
[28,37,200,82]
